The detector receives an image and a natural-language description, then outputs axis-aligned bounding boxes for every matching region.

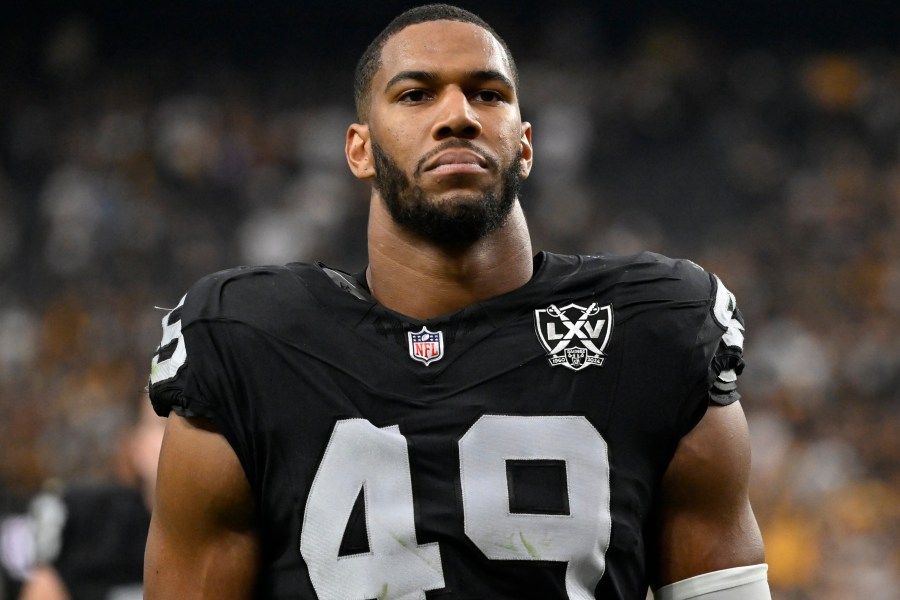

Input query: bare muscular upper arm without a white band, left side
[144,414,259,600]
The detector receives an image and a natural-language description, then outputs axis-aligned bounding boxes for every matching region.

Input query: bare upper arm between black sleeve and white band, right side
[652,402,764,589]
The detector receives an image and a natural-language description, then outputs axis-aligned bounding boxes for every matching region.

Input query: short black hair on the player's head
[353,4,519,123]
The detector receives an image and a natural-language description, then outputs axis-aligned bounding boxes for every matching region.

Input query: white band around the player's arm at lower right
[653,563,772,600]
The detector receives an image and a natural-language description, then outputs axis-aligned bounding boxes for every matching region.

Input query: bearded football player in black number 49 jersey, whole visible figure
[145,5,769,600]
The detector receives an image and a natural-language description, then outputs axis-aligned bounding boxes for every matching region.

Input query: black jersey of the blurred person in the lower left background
[32,484,150,600]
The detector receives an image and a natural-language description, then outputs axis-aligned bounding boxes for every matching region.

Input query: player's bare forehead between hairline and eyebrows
[375,21,512,82]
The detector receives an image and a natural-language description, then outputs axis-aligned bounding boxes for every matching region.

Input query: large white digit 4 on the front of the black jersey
[300,419,444,600]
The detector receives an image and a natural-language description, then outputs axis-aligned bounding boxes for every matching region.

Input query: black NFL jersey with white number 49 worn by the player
[150,253,743,600]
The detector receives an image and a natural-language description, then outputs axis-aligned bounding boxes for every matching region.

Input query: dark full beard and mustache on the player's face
[372,139,522,246]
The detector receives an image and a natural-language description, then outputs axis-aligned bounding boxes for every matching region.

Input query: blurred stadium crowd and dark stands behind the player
[0,0,900,600]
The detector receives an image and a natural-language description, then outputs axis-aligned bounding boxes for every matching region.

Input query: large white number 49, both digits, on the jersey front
[300,415,612,600]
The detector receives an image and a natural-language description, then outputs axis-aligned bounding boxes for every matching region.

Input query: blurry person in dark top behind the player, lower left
[20,394,165,600]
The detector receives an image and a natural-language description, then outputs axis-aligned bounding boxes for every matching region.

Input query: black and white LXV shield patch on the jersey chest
[534,302,613,371]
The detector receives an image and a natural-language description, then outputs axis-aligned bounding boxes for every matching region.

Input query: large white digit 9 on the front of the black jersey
[459,415,612,600]
